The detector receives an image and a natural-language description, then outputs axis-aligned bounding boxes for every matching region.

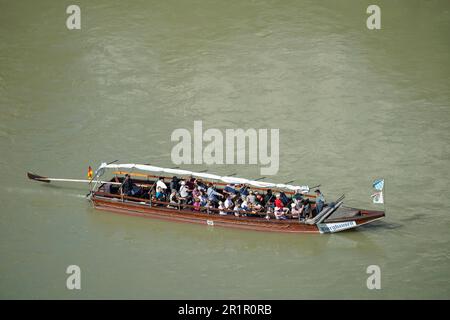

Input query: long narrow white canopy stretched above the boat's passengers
[98,163,309,192]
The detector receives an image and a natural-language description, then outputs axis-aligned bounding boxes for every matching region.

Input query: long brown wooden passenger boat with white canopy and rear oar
[28,163,385,233]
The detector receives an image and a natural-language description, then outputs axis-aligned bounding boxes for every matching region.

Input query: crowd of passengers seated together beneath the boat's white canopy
[143,176,325,220]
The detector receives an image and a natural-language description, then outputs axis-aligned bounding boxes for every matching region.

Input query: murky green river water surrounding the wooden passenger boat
[0,0,450,299]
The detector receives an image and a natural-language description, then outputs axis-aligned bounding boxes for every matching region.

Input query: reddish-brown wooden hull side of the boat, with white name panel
[91,195,384,234]
